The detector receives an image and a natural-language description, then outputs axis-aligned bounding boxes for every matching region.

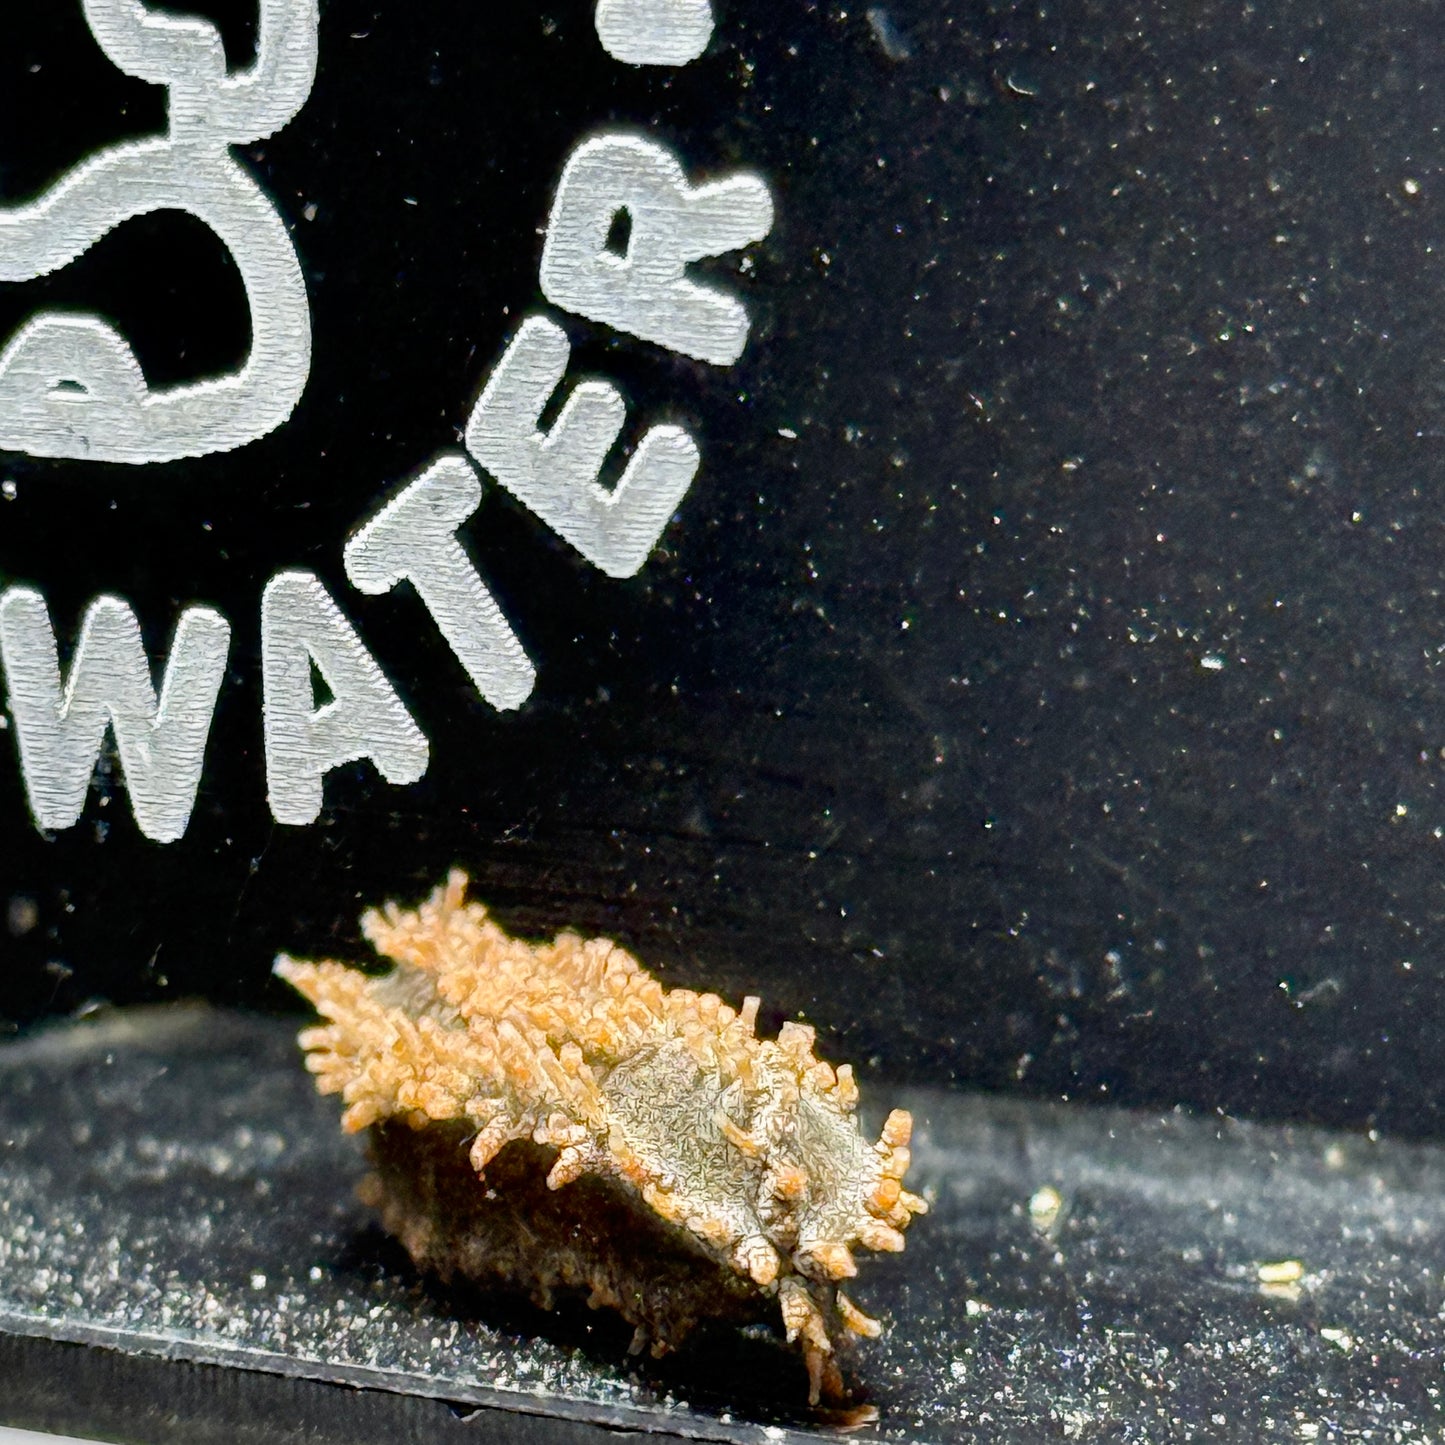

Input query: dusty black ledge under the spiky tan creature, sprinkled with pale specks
[0,1010,1445,1445]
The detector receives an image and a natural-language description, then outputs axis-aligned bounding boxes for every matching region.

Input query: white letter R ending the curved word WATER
[542,134,773,366]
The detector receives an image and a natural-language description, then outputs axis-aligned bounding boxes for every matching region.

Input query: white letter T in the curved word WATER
[345,452,536,711]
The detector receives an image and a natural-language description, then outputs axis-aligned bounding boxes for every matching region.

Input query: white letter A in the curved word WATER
[262,572,428,825]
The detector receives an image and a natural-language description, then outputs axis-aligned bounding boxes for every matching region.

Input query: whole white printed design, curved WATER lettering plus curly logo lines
[0,0,773,842]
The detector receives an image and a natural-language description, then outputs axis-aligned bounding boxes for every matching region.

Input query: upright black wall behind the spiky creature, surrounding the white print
[0,0,1445,1134]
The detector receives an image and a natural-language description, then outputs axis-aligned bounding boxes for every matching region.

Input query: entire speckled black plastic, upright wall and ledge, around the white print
[0,8,1445,1445]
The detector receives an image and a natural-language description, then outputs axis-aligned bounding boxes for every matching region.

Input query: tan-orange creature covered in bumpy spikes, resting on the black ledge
[276,873,926,1405]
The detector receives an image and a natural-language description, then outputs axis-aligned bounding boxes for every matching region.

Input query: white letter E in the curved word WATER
[467,316,701,577]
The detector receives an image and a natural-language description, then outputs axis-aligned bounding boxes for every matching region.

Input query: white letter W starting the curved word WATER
[0,587,231,842]
